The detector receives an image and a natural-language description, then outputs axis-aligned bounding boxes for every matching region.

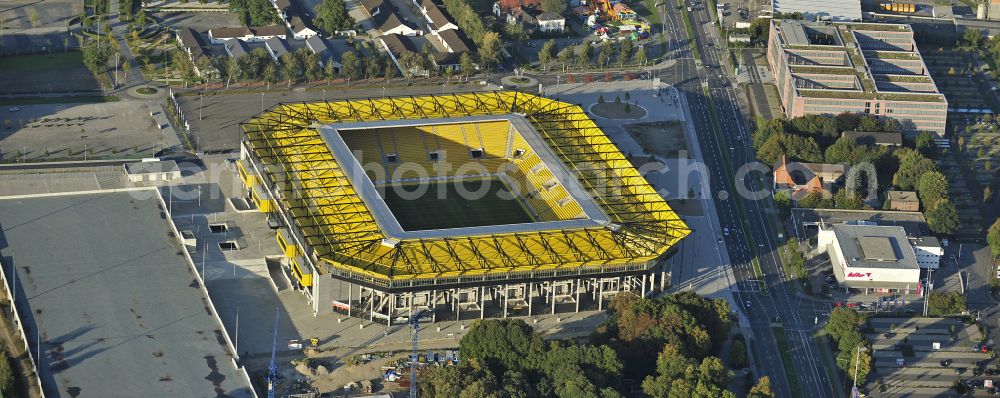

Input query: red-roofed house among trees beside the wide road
[773,157,848,201]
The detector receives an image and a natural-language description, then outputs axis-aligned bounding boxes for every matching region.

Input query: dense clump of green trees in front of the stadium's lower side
[419,293,774,398]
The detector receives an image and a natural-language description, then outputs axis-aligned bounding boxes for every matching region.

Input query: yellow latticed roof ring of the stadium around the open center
[243,91,690,286]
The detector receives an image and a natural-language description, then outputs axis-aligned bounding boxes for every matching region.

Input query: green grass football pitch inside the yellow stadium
[385,179,534,231]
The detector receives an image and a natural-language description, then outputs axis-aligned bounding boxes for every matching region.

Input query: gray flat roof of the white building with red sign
[831,224,918,269]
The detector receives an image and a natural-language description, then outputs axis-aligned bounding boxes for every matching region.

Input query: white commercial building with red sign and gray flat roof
[818,224,920,294]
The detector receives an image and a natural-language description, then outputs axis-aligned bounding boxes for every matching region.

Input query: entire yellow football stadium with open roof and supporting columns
[237,91,690,323]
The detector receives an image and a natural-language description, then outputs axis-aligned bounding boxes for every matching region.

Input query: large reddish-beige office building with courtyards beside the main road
[767,20,948,135]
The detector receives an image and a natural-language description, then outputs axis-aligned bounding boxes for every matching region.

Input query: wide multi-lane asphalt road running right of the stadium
[661,6,841,397]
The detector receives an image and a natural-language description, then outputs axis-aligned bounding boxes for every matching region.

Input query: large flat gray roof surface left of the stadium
[0,189,255,397]
